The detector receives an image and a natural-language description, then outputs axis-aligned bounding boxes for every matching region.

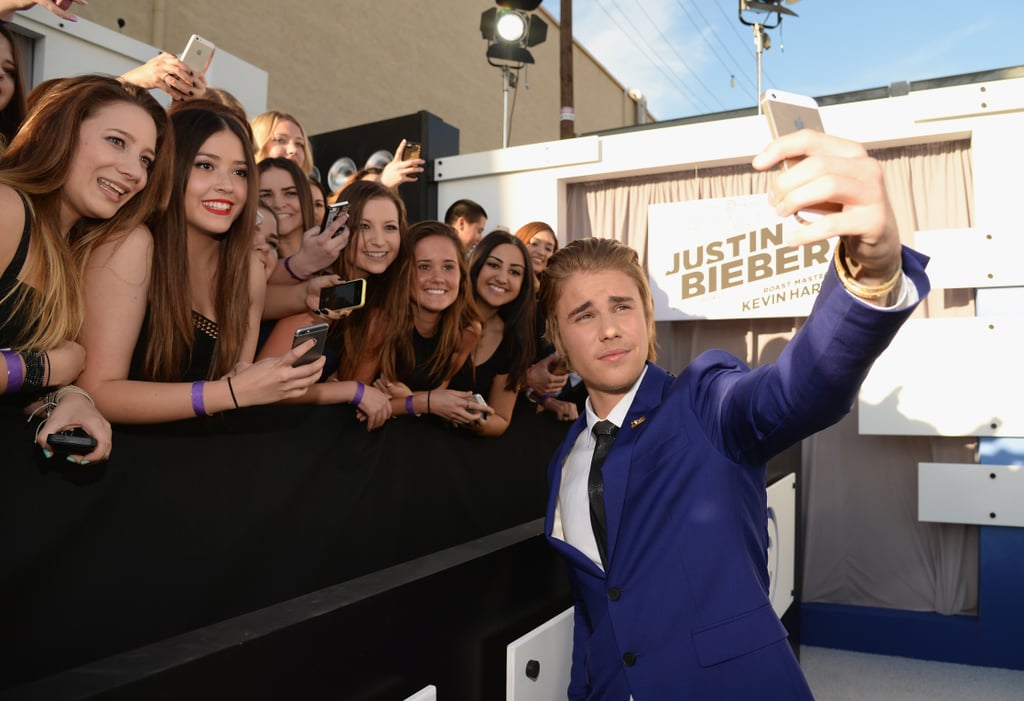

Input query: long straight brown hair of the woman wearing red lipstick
[143,102,259,382]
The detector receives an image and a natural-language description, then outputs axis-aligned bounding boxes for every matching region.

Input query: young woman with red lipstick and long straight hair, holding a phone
[81,103,324,424]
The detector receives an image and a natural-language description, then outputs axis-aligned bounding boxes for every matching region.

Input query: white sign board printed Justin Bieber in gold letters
[647,194,838,321]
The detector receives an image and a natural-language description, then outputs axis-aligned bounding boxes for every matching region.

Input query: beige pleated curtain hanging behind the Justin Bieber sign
[565,140,978,614]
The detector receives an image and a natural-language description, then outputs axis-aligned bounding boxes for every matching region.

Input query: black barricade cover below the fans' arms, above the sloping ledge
[0,403,567,688]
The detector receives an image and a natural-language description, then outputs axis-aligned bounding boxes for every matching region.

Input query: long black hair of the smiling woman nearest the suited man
[469,231,537,392]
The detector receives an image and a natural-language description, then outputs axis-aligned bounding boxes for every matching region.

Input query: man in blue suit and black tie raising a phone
[541,131,929,701]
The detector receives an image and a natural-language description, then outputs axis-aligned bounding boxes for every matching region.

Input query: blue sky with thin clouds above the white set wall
[535,0,1024,120]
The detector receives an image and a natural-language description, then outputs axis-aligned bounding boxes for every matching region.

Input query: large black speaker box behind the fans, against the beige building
[310,111,459,223]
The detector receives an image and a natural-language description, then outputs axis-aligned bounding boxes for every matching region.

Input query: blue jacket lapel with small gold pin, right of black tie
[601,362,671,563]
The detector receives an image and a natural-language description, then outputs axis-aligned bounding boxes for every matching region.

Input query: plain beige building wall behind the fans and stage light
[75,0,647,154]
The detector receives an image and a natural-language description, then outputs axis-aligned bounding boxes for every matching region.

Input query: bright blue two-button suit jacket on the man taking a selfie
[546,249,929,701]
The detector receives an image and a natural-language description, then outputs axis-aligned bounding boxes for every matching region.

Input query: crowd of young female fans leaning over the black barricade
[0,1,578,465]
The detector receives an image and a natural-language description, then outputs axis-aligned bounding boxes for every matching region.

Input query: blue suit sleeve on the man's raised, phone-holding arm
[687,248,930,465]
